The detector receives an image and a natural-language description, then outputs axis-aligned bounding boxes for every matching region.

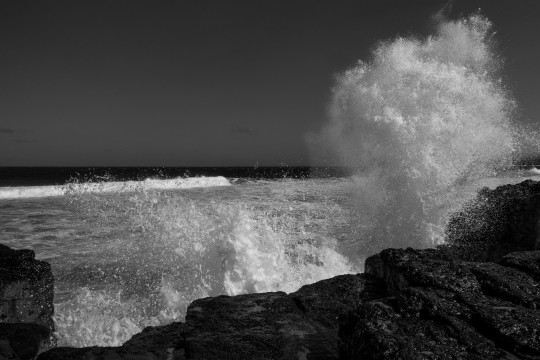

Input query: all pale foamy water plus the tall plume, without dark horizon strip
[0,14,540,346]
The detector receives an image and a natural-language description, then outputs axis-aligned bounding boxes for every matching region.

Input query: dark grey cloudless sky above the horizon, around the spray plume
[0,0,540,166]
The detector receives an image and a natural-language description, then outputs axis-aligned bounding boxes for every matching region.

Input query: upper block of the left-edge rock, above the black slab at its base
[0,244,54,332]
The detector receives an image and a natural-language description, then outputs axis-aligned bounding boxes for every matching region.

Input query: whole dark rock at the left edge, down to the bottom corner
[0,244,54,359]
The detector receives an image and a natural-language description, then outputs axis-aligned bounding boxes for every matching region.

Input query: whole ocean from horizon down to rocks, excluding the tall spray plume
[0,168,540,346]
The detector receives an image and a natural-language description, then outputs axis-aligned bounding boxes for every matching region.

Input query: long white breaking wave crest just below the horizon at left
[0,176,231,199]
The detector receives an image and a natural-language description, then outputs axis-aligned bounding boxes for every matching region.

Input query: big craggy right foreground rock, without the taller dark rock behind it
[340,248,540,359]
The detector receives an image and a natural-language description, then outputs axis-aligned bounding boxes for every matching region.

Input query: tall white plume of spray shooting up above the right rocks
[312,14,519,254]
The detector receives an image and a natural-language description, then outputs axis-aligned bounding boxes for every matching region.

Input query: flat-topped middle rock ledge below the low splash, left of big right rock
[186,275,384,359]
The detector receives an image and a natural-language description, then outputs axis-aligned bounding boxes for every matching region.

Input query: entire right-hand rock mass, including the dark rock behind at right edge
[339,180,540,359]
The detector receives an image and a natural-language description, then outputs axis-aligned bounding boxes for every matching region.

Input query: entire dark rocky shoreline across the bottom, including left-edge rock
[0,180,540,360]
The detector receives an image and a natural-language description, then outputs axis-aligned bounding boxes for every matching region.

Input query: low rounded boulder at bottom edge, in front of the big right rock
[340,301,503,359]
